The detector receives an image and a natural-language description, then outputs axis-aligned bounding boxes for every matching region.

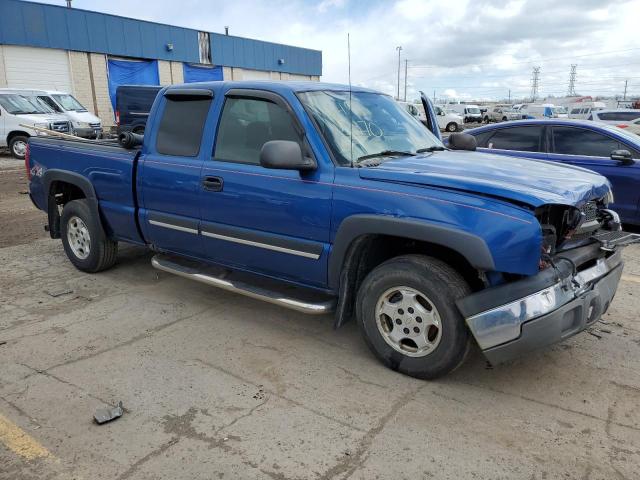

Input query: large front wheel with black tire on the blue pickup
[356,255,471,379]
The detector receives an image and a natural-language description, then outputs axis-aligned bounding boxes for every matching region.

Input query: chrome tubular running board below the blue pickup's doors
[151,255,336,315]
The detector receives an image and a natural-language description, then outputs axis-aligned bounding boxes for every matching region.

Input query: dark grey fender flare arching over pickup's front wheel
[328,214,495,291]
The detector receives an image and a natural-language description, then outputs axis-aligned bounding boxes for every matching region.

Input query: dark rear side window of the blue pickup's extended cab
[156,97,211,157]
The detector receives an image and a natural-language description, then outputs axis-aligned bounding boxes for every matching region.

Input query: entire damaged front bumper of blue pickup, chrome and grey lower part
[458,249,623,363]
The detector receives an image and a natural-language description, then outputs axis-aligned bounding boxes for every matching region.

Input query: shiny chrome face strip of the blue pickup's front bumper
[466,250,622,350]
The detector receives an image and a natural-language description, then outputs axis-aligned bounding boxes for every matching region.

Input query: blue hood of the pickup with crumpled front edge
[360,150,610,208]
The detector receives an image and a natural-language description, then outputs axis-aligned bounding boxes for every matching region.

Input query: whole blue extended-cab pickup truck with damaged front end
[26,82,636,378]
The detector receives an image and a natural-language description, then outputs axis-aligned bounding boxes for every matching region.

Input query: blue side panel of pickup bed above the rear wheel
[29,137,143,243]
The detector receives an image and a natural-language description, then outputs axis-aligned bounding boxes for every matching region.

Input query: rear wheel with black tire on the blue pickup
[60,199,118,273]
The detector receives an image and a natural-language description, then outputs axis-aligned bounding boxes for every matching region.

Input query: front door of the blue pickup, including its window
[200,89,333,287]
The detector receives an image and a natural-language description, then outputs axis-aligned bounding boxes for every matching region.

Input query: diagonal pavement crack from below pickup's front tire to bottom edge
[318,384,428,480]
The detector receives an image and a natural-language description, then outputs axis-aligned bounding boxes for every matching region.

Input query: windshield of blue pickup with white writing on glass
[298,90,443,166]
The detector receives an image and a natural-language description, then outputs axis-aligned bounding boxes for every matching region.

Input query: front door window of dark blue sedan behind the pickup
[553,127,624,157]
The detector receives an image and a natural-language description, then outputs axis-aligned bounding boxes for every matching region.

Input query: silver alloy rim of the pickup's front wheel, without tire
[375,287,442,357]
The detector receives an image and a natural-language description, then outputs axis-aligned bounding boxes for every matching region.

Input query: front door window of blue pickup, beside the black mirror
[215,98,301,165]
